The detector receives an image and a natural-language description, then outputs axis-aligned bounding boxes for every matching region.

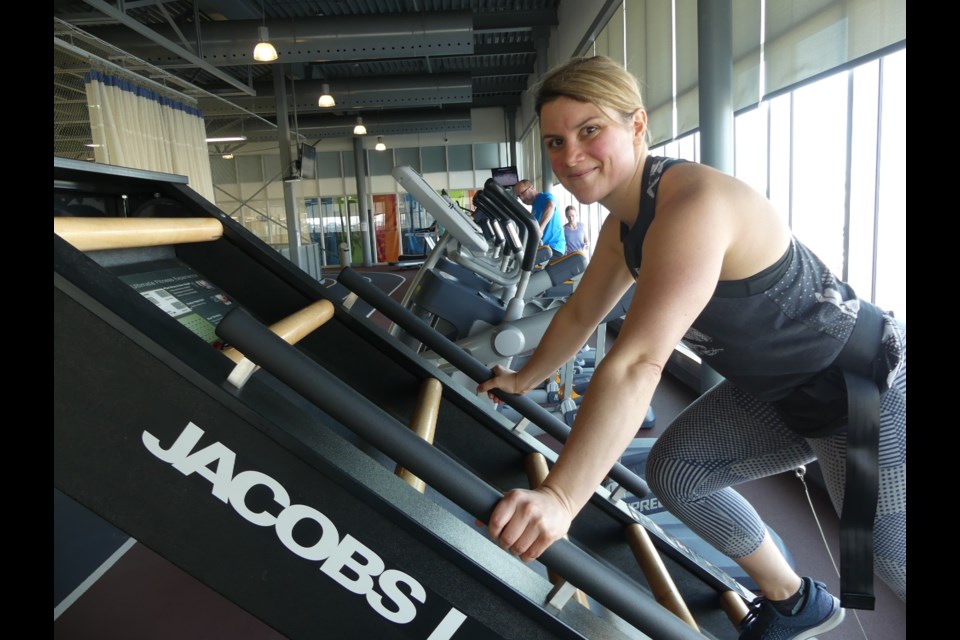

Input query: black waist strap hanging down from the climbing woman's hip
[834,301,883,610]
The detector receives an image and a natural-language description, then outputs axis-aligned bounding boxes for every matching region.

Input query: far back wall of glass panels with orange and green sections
[211,143,509,265]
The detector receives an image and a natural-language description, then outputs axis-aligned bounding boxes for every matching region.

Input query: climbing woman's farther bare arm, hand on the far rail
[477,216,634,399]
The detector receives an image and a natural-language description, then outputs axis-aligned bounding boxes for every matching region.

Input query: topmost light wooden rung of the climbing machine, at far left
[53,216,223,251]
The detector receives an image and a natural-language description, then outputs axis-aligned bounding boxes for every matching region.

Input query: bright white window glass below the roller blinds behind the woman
[648,50,907,319]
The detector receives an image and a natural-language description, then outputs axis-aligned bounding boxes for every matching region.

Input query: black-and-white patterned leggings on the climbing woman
[646,323,907,602]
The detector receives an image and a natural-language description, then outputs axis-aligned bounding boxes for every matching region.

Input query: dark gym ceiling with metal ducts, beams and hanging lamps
[54,0,560,156]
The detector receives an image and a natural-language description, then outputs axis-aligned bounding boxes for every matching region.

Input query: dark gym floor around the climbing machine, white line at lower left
[54,267,907,640]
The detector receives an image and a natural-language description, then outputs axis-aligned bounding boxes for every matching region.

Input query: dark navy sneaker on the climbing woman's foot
[740,578,844,640]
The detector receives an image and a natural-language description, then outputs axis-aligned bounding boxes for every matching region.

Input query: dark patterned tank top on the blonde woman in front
[620,157,888,401]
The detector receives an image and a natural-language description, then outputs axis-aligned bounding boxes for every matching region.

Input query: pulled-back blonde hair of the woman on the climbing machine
[534,56,643,125]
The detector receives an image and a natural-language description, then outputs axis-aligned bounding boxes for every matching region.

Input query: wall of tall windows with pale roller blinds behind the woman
[536,0,907,319]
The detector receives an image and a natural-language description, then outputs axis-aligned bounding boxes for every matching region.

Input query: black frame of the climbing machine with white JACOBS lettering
[54,159,749,638]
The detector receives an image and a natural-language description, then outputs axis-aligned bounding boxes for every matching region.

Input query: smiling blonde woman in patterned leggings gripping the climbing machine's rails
[478,56,906,640]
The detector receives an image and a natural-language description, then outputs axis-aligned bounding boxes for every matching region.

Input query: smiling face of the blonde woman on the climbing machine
[540,97,646,204]
